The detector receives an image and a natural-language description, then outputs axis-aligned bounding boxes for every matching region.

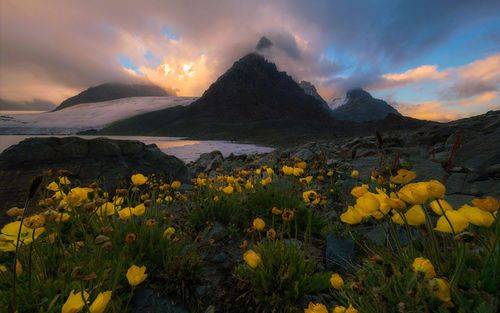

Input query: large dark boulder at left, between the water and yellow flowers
[0,137,187,209]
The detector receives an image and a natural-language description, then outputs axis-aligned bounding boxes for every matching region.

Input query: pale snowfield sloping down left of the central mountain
[0,96,197,135]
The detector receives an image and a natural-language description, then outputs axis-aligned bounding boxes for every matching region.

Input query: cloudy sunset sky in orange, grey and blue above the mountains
[0,0,500,121]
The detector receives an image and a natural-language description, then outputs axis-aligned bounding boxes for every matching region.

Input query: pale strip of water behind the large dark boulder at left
[0,135,273,162]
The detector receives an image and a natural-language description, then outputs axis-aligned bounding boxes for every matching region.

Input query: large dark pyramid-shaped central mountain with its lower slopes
[95,53,427,144]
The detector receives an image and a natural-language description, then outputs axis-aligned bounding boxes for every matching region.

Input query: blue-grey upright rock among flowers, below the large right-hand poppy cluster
[325,233,355,272]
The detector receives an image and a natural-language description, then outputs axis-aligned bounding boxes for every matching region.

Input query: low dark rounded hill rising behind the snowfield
[55,83,169,111]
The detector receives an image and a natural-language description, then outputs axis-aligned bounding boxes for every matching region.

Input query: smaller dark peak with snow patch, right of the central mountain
[332,88,401,122]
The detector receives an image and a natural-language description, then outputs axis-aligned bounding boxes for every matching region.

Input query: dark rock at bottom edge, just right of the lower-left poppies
[131,287,189,313]
